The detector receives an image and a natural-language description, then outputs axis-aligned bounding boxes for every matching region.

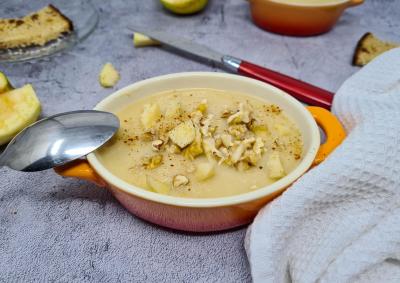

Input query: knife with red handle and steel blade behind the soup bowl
[131,27,334,109]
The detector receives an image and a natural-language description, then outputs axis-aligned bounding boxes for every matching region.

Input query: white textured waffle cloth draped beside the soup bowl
[246,49,400,282]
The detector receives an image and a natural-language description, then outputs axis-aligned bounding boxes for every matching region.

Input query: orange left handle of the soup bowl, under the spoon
[54,159,106,187]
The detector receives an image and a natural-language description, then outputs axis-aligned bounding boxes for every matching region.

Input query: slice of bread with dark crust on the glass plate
[0,5,73,49]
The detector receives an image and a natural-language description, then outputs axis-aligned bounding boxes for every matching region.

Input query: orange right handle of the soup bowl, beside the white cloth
[307,106,346,165]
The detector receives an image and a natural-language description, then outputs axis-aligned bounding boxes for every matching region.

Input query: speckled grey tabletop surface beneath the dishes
[0,0,400,282]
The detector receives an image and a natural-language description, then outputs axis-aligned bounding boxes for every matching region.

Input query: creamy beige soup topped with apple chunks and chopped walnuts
[97,89,303,198]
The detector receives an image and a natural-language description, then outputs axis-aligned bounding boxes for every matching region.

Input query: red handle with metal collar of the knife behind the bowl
[222,56,334,109]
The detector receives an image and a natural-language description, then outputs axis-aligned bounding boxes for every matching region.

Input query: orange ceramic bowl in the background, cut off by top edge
[249,0,364,36]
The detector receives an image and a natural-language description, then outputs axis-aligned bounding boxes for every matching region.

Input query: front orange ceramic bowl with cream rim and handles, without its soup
[56,72,345,232]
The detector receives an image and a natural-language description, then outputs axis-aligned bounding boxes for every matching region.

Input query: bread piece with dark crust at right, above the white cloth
[353,32,400,66]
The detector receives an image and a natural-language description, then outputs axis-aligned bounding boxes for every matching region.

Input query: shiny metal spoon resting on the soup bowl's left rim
[0,110,119,172]
